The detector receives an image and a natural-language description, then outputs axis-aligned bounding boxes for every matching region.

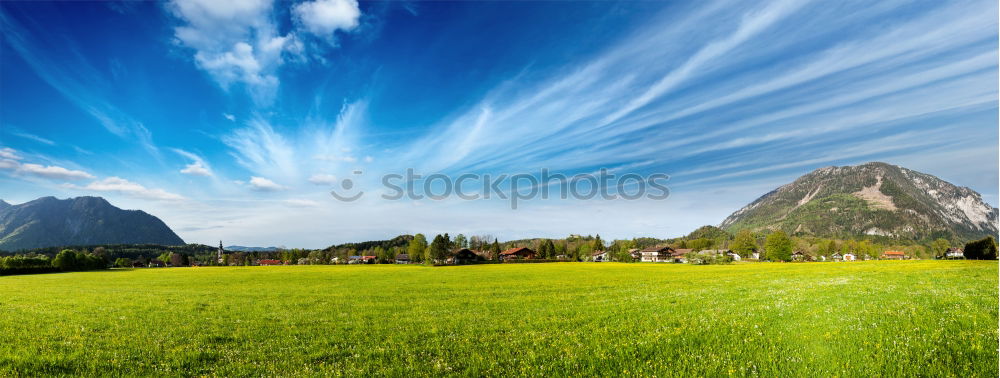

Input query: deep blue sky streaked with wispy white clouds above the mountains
[0,0,998,247]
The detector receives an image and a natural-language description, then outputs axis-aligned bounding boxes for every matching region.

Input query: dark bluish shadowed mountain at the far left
[0,197,184,251]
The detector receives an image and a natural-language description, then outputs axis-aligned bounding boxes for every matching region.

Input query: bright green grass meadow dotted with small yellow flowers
[0,261,998,377]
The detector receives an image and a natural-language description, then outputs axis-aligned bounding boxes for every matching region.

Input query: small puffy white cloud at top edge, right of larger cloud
[292,0,361,37]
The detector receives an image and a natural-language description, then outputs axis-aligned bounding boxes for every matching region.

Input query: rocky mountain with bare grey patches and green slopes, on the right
[719,162,997,240]
